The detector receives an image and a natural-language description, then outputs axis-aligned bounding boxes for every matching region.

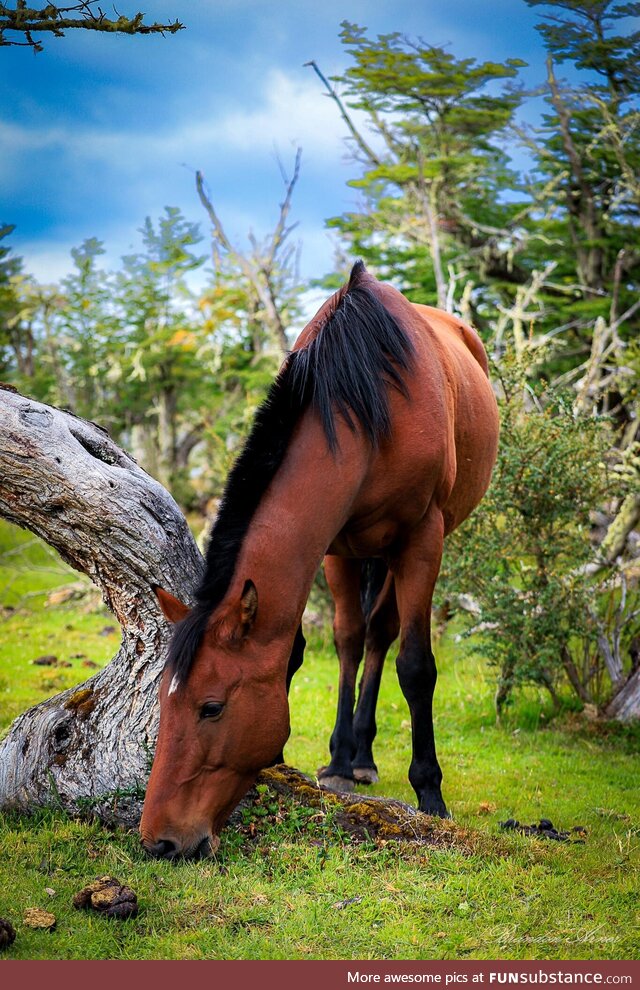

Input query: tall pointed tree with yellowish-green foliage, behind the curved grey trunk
[110,207,213,489]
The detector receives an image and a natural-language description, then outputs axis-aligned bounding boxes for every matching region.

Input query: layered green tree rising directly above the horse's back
[310,21,523,309]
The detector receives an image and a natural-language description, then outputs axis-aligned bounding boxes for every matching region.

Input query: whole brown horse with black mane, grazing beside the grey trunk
[140,263,498,858]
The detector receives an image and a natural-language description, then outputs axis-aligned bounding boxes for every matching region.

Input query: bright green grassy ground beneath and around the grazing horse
[0,528,640,959]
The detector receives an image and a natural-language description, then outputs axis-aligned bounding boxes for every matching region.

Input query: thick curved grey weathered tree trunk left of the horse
[0,388,202,820]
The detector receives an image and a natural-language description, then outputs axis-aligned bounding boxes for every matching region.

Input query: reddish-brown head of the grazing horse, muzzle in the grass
[140,581,289,859]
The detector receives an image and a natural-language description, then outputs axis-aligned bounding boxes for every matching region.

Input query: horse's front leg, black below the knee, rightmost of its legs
[391,509,447,818]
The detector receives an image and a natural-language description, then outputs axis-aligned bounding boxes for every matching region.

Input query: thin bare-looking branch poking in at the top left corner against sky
[0,0,184,52]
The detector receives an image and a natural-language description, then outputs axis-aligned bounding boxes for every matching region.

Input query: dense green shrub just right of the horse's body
[441,360,628,712]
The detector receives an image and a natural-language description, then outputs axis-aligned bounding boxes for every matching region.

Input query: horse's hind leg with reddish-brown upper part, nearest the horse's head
[318,556,365,791]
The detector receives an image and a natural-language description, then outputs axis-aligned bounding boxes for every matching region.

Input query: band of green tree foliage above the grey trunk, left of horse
[0,207,286,507]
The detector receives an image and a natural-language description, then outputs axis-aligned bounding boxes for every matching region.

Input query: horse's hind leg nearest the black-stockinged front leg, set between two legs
[353,573,400,784]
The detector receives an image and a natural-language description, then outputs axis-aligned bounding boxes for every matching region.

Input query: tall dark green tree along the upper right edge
[521,0,640,376]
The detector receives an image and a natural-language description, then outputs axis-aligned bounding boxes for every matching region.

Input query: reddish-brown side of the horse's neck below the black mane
[233,416,368,635]
